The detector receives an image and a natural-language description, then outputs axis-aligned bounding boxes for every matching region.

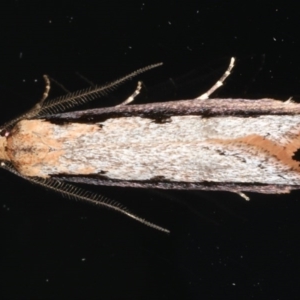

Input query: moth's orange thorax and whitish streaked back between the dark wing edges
[2,106,300,185]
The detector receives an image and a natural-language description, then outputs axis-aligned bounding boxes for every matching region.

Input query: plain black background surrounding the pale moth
[0,0,300,299]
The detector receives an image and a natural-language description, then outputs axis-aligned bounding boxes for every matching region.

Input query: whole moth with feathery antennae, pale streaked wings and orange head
[0,58,300,232]
